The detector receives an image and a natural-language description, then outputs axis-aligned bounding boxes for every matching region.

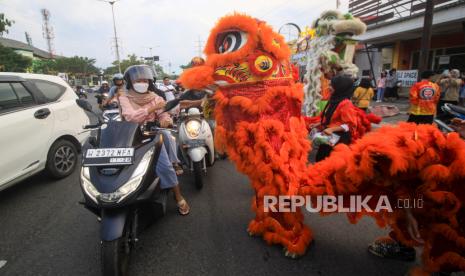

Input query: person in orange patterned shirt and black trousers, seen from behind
[407,71,441,124]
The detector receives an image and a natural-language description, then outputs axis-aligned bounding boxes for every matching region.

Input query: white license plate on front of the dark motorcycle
[83,148,134,167]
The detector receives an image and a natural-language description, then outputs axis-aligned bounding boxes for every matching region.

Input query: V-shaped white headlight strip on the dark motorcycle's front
[81,148,155,203]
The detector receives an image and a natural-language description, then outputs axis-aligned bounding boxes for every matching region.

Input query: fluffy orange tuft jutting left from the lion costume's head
[179,65,215,89]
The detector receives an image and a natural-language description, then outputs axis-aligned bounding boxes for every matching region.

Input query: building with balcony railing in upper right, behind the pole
[349,0,465,78]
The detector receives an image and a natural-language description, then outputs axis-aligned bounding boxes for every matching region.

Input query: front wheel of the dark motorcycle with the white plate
[101,233,131,276]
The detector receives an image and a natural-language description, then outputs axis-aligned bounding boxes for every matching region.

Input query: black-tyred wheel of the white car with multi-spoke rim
[46,140,78,179]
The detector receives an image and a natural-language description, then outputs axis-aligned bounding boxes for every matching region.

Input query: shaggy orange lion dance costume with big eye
[180,14,465,271]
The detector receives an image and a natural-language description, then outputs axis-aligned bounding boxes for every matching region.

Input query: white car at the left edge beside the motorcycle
[0,73,89,190]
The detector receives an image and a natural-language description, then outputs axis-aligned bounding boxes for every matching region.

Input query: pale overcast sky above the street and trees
[0,0,348,72]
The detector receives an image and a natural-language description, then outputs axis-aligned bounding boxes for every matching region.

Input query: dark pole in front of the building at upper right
[418,0,434,79]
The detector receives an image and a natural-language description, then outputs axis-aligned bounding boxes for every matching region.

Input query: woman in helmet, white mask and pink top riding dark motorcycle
[118,65,190,215]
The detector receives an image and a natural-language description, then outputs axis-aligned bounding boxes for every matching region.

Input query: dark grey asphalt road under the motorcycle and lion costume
[0,94,415,275]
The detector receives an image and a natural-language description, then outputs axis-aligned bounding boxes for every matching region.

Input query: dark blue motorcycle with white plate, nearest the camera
[77,100,168,276]
